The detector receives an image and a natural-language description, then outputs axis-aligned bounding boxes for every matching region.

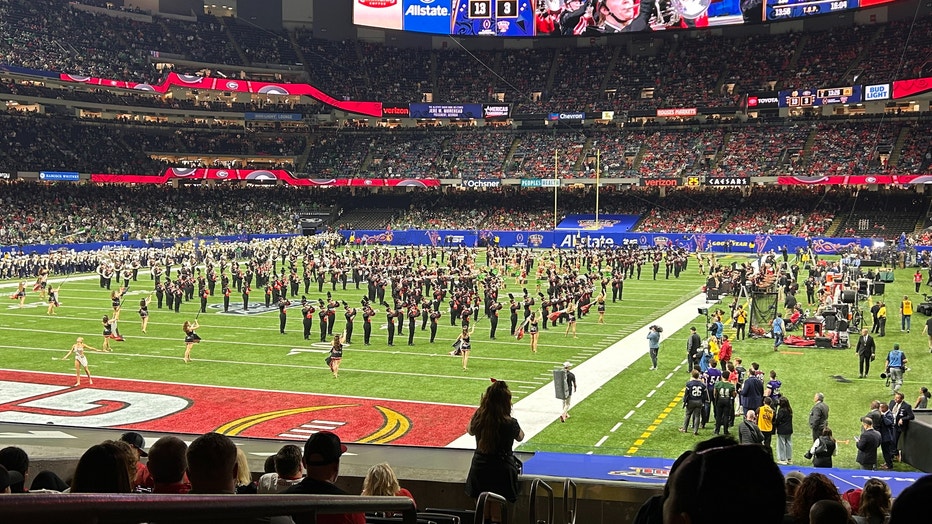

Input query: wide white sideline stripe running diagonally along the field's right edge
[446,293,711,449]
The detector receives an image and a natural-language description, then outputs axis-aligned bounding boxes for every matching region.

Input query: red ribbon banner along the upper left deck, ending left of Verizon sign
[59,72,382,117]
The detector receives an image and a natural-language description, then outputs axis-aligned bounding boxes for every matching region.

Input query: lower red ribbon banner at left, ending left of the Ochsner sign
[91,167,440,188]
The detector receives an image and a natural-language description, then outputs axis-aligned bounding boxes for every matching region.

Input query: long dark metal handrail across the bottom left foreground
[0,493,417,524]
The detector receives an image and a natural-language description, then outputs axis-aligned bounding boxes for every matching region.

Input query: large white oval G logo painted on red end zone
[0,382,190,427]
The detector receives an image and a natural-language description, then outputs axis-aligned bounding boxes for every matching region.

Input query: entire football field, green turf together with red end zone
[0,252,932,468]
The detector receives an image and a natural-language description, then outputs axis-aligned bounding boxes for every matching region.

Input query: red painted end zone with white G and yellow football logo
[0,370,475,447]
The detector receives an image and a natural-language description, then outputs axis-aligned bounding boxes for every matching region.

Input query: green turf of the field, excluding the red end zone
[0,252,932,467]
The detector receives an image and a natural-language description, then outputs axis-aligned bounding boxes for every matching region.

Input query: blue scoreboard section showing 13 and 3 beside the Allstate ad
[452,0,534,36]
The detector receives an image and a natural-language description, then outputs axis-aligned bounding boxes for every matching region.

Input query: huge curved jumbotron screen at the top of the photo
[353,0,894,37]
